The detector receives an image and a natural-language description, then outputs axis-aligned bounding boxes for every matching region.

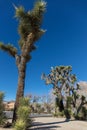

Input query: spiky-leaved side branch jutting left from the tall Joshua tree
[0,42,17,57]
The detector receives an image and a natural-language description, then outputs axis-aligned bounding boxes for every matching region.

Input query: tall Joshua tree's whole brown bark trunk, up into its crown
[12,33,34,122]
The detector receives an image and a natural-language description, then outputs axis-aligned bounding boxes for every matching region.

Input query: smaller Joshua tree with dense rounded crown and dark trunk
[42,66,76,111]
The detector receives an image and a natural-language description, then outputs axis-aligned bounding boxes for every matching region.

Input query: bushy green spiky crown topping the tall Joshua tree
[15,0,46,48]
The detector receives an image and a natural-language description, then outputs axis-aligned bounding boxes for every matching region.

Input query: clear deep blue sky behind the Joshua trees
[0,0,87,100]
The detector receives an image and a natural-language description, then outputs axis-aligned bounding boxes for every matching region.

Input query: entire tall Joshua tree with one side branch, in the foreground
[0,0,46,120]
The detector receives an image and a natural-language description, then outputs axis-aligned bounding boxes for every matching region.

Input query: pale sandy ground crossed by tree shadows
[0,117,87,130]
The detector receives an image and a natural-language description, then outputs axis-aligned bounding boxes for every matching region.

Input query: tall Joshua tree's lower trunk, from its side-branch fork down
[13,57,26,122]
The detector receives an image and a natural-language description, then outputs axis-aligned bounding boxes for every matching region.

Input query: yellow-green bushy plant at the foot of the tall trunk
[14,97,32,130]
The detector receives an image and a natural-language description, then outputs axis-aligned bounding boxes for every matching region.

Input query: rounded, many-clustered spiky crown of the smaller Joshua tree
[42,66,77,95]
